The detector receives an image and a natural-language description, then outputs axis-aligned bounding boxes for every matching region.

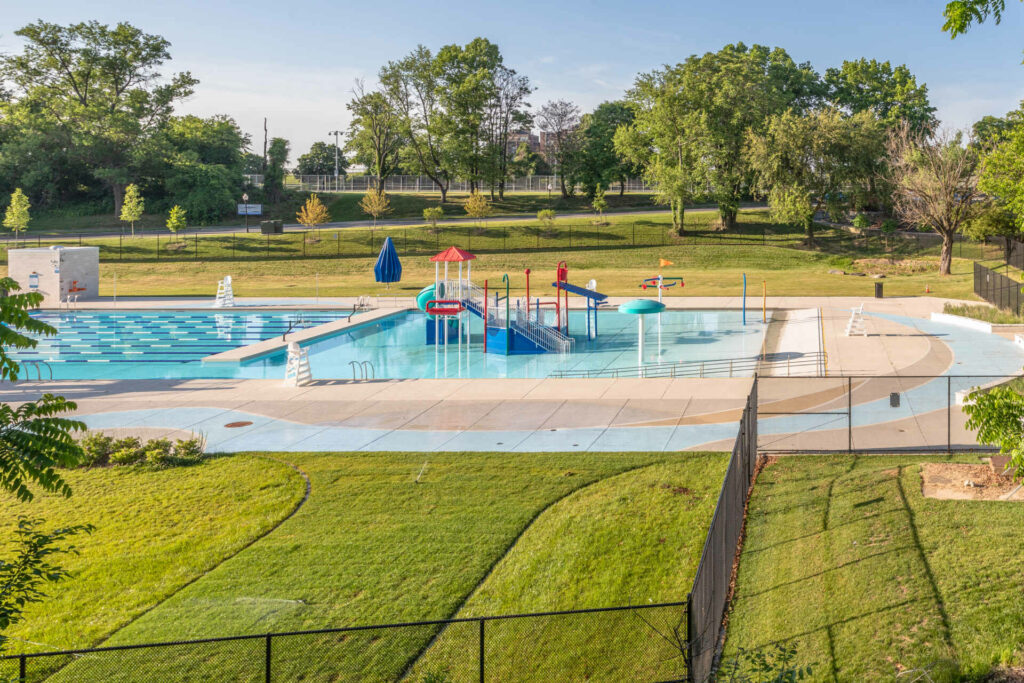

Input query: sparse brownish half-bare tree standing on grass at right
[888,125,978,275]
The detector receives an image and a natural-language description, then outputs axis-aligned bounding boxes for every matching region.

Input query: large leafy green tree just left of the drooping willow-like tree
[672,43,821,228]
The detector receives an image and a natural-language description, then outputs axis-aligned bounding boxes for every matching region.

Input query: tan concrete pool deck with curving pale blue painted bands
[0,297,1024,452]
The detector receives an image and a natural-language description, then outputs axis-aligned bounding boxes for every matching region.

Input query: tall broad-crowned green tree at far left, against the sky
[0,20,198,216]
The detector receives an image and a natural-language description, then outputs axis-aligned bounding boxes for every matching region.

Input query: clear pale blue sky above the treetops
[0,0,1024,160]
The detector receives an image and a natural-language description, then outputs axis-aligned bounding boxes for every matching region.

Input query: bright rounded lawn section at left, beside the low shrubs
[0,456,305,655]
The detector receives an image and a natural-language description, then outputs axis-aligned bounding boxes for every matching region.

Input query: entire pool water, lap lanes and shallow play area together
[15,310,766,379]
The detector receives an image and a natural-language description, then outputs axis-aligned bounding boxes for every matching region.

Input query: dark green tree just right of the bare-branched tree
[578,101,640,197]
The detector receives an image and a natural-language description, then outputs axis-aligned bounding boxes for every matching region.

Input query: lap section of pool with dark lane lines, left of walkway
[11,309,349,379]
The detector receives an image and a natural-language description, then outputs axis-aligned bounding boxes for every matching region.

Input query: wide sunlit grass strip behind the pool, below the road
[2,210,999,299]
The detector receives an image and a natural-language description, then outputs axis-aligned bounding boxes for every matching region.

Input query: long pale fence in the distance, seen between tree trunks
[245,175,653,195]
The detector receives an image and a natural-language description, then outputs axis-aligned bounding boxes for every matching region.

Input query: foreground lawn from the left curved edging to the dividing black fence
[9,453,726,681]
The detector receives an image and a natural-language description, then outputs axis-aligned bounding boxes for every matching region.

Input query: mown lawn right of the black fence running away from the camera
[726,456,1024,683]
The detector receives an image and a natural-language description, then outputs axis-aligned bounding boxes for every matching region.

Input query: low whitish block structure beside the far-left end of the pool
[7,247,99,307]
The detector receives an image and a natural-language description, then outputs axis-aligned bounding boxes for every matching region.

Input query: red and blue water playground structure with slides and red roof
[416,247,608,355]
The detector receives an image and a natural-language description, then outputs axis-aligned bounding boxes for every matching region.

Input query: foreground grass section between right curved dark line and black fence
[413,454,728,681]
